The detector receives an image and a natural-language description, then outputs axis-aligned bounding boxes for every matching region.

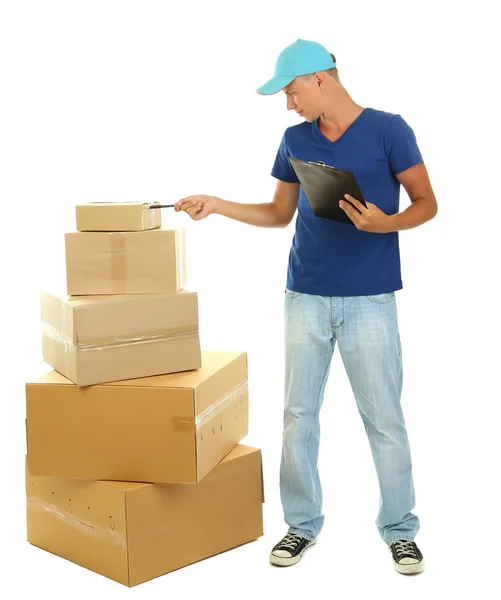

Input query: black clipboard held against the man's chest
[289,157,367,225]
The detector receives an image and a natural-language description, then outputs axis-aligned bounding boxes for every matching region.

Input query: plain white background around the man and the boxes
[0,0,501,598]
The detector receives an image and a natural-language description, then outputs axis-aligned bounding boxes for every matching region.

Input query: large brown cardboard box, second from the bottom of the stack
[26,351,249,483]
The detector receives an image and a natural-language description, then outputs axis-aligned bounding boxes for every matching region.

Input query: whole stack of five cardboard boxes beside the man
[26,203,264,586]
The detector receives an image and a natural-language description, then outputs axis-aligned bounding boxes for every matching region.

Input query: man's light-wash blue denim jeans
[280,289,419,544]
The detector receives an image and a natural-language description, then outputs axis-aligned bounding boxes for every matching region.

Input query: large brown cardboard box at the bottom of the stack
[26,445,264,586]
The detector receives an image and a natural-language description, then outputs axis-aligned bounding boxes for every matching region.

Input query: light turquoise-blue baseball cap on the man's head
[257,39,336,95]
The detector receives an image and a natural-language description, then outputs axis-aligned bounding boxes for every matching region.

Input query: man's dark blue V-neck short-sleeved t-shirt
[271,108,423,296]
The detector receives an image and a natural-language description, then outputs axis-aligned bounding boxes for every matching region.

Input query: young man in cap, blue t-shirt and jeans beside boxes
[176,39,437,574]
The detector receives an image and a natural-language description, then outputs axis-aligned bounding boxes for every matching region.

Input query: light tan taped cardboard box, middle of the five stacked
[41,290,202,386]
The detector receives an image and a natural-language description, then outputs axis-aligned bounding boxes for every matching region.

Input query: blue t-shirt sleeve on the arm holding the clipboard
[385,115,423,175]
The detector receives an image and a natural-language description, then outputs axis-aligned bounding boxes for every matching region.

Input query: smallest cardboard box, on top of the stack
[75,202,162,231]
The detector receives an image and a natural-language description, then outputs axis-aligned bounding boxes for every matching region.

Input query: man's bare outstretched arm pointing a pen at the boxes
[176,180,299,227]
